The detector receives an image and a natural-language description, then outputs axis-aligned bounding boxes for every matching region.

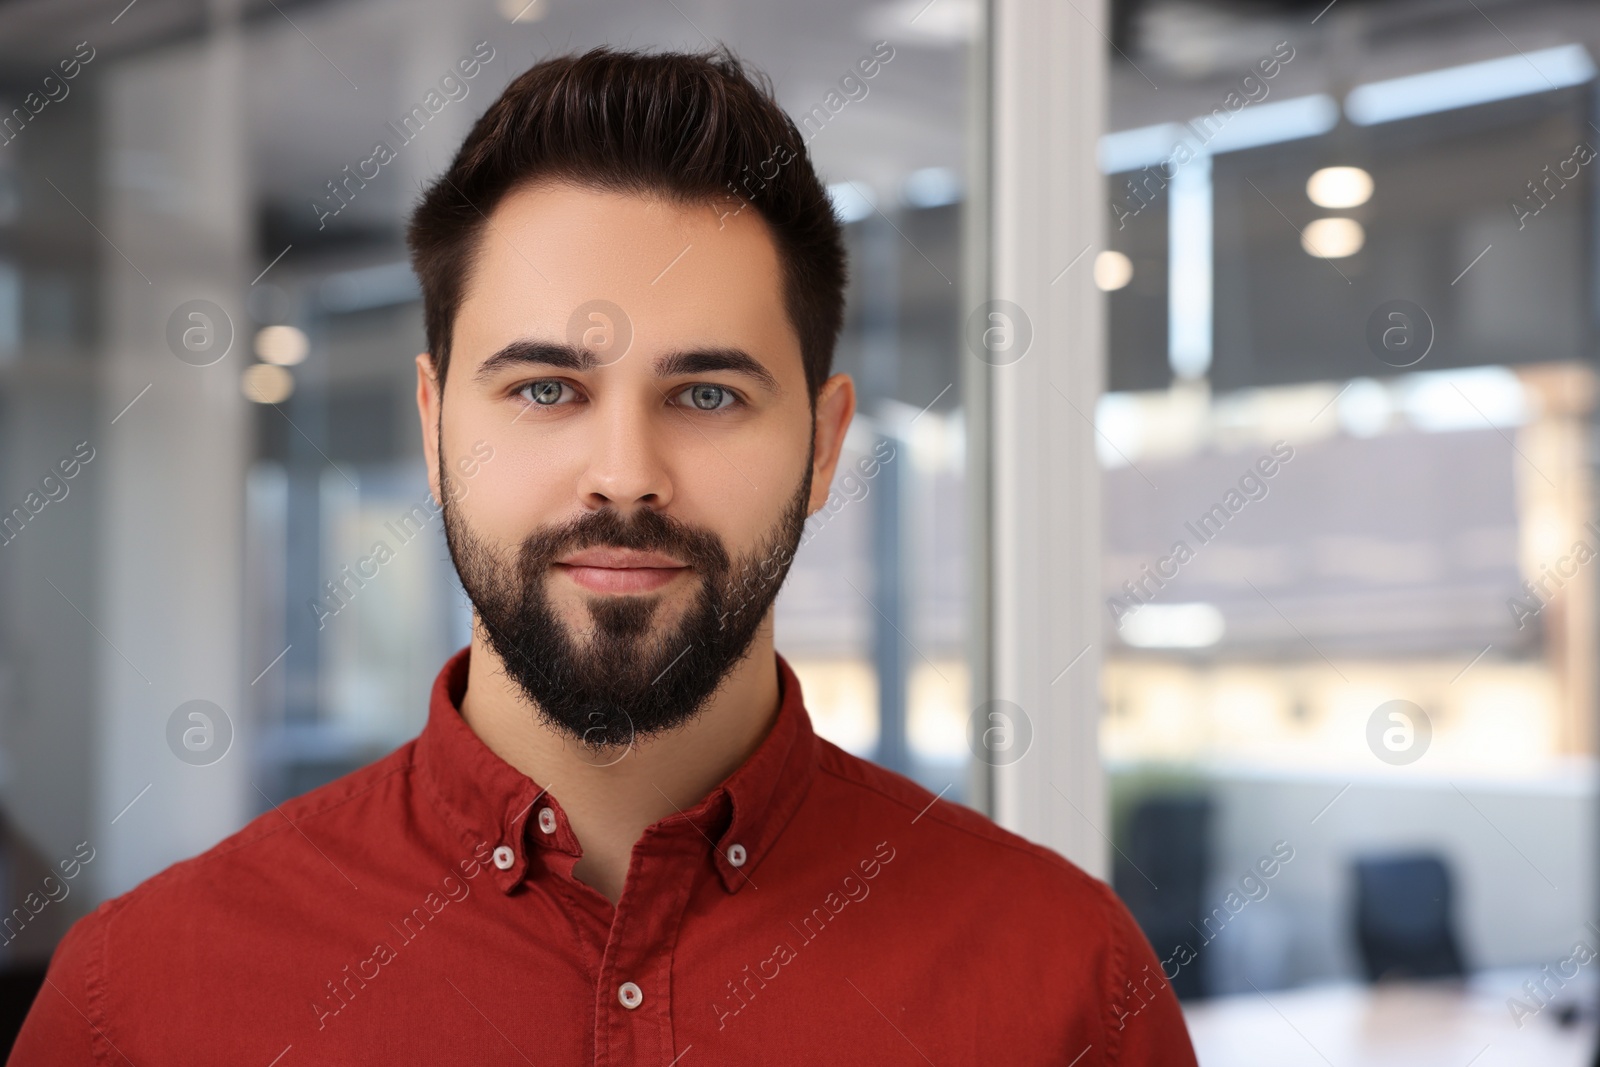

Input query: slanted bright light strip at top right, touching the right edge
[1344,45,1595,126]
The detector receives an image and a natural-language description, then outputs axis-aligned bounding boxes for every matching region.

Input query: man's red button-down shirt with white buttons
[10,649,1195,1067]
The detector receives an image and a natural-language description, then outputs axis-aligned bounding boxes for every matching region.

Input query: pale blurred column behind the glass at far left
[90,18,249,896]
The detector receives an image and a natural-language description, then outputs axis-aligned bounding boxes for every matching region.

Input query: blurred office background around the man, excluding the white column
[0,0,1600,1067]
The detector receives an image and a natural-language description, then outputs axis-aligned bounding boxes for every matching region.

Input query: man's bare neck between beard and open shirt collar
[461,614,778,904]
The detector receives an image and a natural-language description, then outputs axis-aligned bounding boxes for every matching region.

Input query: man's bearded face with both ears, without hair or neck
[418,184,853,747]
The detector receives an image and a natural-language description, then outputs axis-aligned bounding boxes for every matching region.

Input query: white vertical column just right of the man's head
[990,0,1110,877]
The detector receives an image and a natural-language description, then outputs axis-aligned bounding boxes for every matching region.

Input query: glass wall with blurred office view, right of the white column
[1096,3,1600,1064]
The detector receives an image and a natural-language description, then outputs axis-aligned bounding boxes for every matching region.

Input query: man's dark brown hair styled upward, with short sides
[406,45,846,411]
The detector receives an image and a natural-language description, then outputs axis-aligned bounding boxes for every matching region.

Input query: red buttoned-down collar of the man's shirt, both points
[413,646,816,893]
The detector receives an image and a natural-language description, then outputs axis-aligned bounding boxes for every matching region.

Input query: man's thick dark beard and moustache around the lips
[438,441,811,751]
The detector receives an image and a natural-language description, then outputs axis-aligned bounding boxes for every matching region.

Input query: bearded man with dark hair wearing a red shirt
[11,50,1194,1067]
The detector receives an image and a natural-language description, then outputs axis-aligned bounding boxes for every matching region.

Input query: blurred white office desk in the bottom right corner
[1184,965,1597,1067]
